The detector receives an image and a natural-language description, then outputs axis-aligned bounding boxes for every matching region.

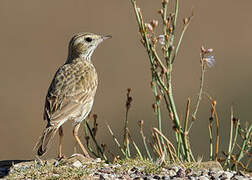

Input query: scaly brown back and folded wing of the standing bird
[44,61,97,123]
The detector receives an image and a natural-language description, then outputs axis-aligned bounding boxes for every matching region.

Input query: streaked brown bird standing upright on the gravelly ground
[35,32,112,158]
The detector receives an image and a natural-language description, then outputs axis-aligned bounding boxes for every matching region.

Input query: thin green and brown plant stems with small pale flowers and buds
[83,0,252,171]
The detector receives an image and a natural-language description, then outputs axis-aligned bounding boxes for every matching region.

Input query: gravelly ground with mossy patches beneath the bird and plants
[0,155,252,180]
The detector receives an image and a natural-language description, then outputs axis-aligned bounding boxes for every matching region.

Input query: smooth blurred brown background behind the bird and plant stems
[0,0,252,160]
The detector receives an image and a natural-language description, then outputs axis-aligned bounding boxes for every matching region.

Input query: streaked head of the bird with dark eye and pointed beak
[68,32,111,61]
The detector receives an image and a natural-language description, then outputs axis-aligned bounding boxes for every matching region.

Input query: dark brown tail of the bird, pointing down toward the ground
[34,125,58,156]
